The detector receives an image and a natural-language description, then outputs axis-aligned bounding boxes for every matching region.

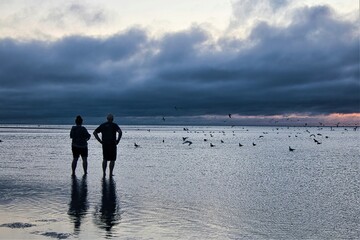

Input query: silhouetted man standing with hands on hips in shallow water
[94,114,122,177]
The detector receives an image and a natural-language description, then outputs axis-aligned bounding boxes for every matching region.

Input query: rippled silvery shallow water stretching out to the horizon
[0,126,360,239]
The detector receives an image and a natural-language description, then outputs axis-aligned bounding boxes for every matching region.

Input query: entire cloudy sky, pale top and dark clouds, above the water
[0,0,360,124]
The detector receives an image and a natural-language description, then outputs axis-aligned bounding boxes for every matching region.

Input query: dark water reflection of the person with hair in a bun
[68,175,89,233]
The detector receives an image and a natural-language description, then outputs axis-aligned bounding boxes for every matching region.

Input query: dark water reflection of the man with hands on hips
[95,178,120,236]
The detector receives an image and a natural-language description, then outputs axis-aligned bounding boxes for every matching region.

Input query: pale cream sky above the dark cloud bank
[0,0,359,40]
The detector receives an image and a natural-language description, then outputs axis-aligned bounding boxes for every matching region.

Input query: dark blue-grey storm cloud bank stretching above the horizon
[0,7,360,124]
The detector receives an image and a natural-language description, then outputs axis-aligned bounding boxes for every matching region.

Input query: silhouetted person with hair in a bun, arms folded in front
[70,116,91,175]
